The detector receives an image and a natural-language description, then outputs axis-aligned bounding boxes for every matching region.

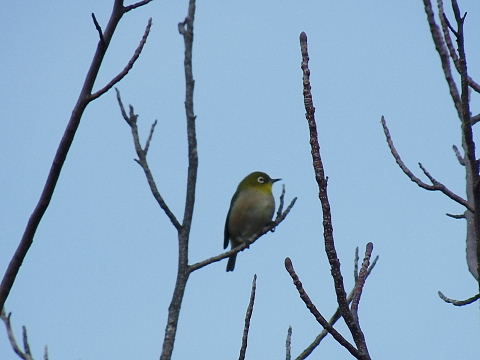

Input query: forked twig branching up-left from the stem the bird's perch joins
[115,88,182,231]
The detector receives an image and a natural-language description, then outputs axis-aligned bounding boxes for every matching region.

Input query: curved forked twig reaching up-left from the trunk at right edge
[381,116,473,211]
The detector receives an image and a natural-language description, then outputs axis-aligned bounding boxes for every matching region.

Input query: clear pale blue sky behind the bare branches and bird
[0,0,480,360]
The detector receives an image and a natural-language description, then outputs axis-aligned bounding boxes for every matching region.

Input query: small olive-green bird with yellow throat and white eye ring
[223,171,281,271]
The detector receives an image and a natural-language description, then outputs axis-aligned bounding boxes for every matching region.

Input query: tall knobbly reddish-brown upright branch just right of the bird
[300,32,370,359]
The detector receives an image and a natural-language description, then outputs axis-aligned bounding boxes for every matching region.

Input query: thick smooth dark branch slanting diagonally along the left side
[0,0,153,309]
